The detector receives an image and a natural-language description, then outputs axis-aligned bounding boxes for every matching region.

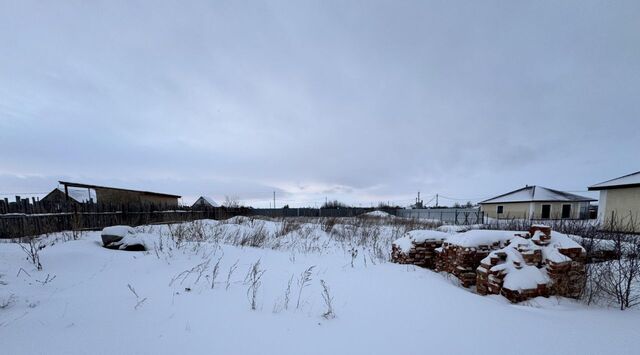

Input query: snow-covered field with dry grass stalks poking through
[0,217,640,355]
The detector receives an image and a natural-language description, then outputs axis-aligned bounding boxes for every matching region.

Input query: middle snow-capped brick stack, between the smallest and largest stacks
[436,230,520,287]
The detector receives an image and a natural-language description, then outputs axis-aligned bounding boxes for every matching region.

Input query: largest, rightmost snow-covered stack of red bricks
[476,226,585,302]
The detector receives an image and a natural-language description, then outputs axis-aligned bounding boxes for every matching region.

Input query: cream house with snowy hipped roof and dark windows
[480,186,595,219]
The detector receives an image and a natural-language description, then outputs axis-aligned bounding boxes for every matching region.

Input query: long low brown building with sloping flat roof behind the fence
[43,181,182,207]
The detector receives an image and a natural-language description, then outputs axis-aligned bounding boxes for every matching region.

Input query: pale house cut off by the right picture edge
[589,171,640,232]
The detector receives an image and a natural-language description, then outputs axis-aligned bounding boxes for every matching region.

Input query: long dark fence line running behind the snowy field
[0,197,482,238]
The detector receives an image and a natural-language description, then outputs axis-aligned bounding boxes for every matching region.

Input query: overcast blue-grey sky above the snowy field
[0,0,640,206]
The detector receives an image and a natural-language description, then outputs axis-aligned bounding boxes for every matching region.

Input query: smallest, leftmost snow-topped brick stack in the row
[391,230,450,269]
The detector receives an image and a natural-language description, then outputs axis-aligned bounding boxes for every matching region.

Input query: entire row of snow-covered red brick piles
[391,225,586,302]
